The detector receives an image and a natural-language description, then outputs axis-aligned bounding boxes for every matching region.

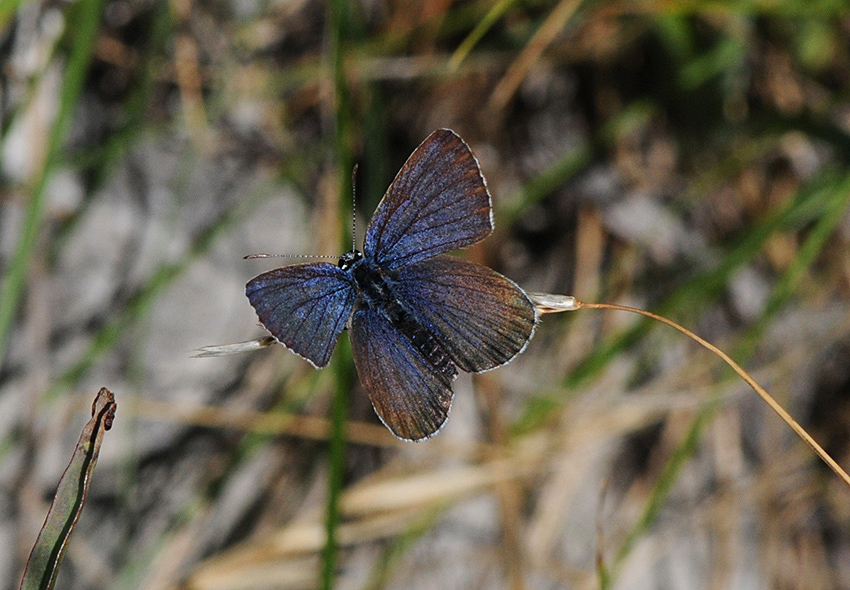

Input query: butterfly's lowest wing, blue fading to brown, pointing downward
[349,309,454,440]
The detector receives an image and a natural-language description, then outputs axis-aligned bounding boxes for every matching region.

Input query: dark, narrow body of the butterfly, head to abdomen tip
[339,250,457,380]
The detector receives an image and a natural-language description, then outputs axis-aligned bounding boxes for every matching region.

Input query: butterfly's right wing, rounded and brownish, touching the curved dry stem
[394,256,537,372]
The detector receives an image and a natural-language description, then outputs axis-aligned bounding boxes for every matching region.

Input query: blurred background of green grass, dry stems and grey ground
[0,0,850,590]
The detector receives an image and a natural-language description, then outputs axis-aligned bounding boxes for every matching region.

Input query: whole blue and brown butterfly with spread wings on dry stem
[245,129,537,440]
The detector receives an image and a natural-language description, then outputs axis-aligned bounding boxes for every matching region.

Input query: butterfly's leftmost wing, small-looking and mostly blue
[245,262,355,367]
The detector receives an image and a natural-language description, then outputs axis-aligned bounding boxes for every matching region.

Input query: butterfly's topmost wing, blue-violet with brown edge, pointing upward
[363,129,493,270]
